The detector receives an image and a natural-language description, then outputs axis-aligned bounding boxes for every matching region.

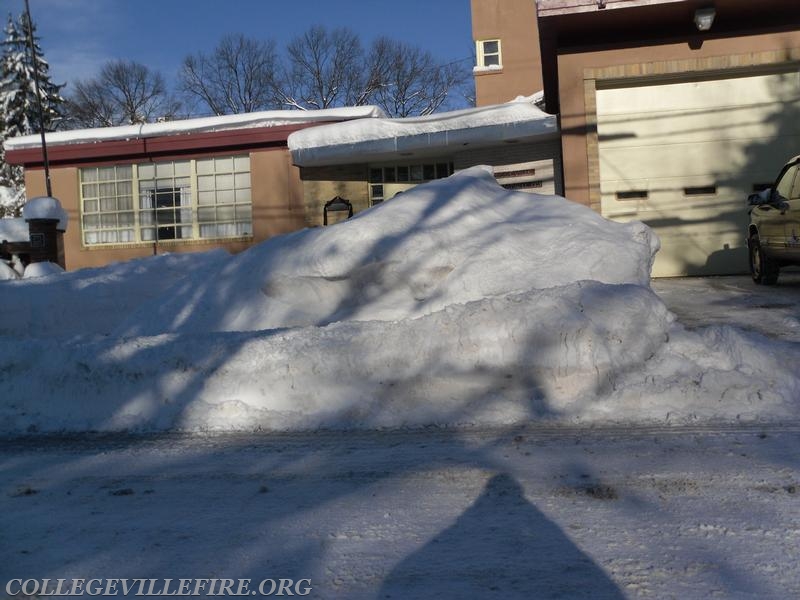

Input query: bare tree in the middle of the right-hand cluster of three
[277,25,370,109]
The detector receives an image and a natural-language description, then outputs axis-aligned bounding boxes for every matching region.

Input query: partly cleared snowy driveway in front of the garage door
[651,269,800,342]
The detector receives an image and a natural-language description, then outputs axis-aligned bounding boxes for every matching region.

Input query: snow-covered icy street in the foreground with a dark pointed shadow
[0,425,800,600]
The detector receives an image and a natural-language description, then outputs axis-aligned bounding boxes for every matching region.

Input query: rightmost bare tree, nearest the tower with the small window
[370,37,471,117]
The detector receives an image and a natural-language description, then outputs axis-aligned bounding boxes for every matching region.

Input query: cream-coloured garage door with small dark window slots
[597,72,800,277]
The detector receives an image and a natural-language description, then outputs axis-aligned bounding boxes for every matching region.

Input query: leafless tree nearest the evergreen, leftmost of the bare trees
[66,60,179,127]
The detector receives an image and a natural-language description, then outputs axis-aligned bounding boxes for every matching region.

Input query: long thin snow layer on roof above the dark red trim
[3,106,386,150]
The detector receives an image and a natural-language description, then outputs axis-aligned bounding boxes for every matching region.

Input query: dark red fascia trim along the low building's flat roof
[6,122,330,168]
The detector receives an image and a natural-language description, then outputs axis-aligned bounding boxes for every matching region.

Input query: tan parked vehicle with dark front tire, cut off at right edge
[747,156,800,285]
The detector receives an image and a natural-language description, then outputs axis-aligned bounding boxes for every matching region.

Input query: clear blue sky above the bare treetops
[9,0,473,91]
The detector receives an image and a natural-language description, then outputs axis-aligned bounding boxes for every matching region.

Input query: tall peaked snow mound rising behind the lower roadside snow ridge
[117,167,658,336]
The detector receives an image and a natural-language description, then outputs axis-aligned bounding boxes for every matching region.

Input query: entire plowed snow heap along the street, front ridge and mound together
[0,167,800,432]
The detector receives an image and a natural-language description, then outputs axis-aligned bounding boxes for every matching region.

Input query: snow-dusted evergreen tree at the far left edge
[0,13,64,216]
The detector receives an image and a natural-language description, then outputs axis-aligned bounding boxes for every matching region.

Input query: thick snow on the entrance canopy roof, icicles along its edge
[288,95,558,167]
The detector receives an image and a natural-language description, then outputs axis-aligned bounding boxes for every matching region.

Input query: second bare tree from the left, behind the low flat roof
[179,34,277,115]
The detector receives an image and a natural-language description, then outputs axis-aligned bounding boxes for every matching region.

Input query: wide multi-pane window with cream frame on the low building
[80,156,253,246]
